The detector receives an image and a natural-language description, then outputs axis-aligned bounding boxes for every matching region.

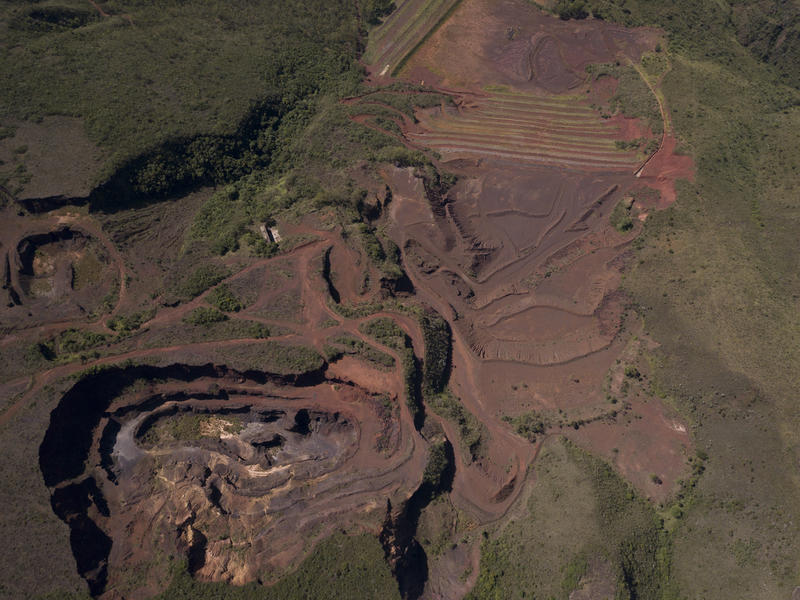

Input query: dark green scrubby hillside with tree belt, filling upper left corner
[0,0,368,193]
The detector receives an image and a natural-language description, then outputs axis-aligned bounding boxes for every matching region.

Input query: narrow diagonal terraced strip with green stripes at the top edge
[364,0,461,76]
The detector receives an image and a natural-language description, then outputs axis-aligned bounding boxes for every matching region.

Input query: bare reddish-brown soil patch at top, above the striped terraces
[401,0,658,94]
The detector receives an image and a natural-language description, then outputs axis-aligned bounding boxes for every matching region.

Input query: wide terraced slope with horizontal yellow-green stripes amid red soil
[408,92,642,171]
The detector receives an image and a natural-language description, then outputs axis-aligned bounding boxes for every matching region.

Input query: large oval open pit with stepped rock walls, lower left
[40,365,426,598]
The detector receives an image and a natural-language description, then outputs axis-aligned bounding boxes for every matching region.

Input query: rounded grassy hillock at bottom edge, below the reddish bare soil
[467,440,675,600]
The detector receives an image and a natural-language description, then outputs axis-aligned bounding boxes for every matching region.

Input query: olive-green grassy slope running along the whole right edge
[580,0,800,599]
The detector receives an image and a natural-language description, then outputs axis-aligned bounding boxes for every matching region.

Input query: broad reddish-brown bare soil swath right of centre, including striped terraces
[366,1,691,597]
